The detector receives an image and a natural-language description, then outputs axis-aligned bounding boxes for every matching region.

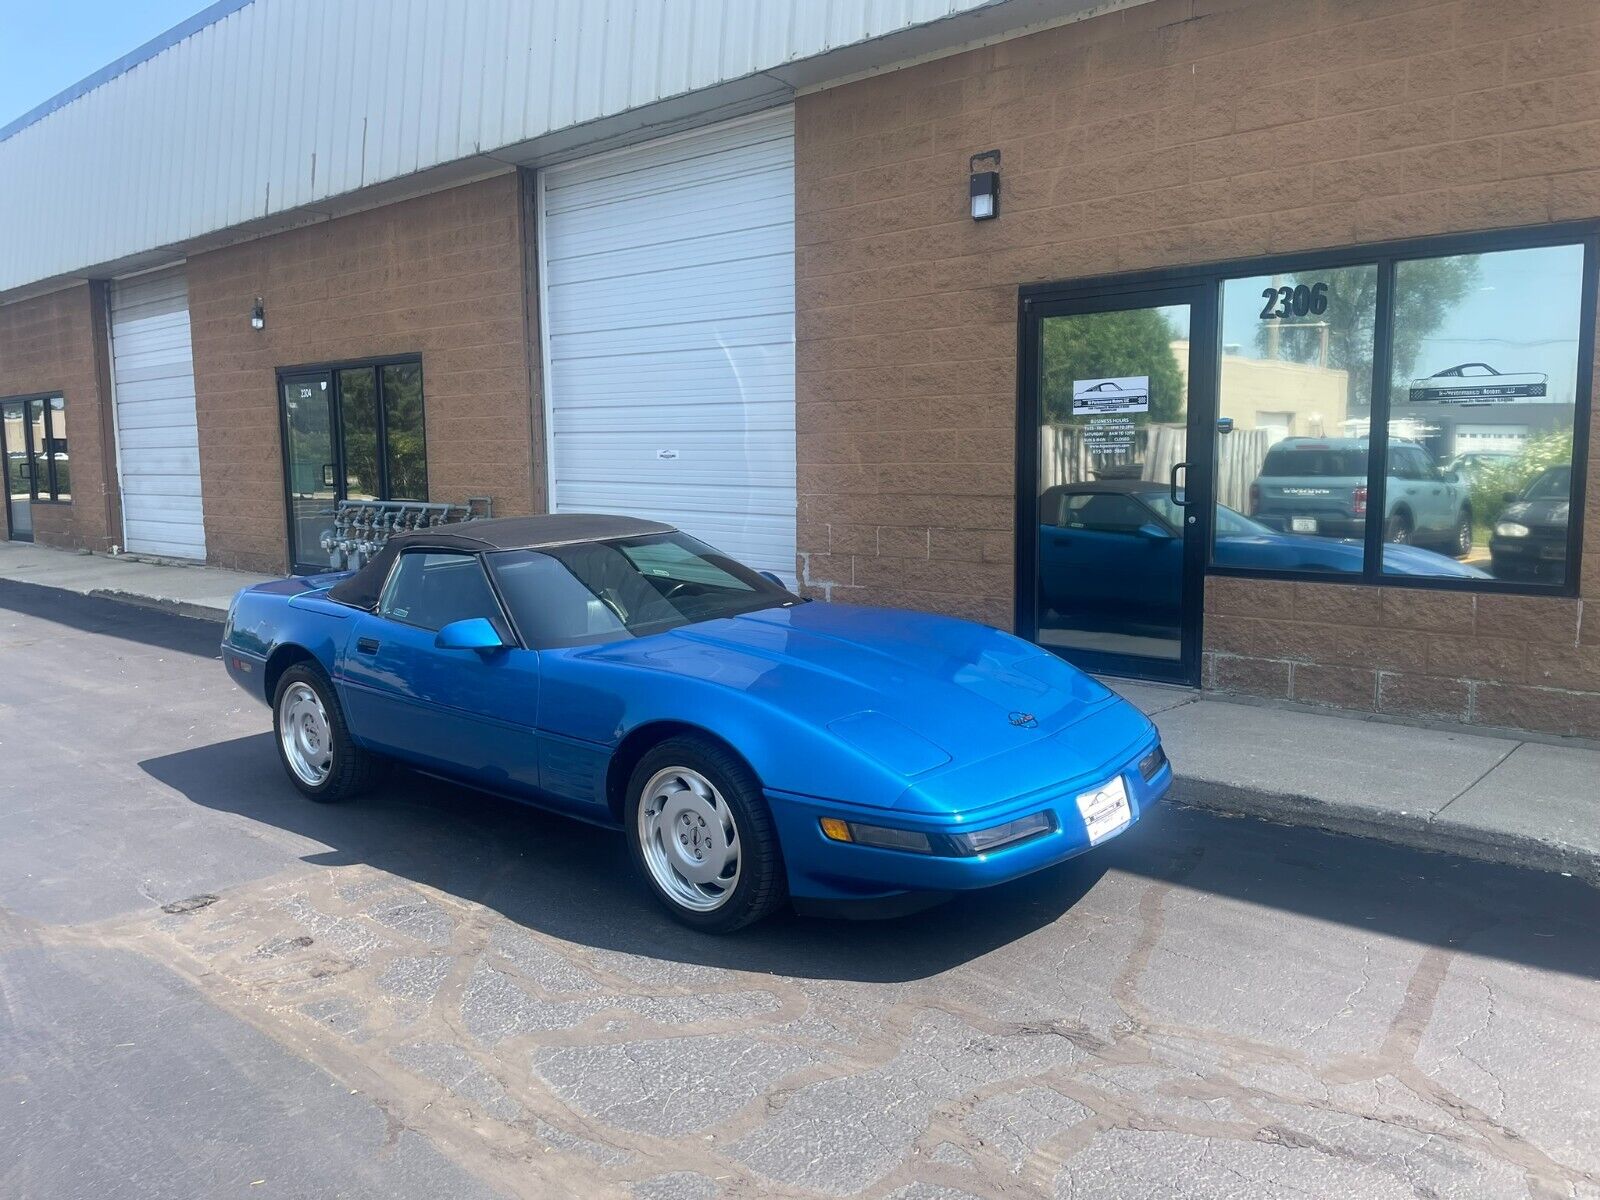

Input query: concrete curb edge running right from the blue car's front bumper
[1168,776,1600,886]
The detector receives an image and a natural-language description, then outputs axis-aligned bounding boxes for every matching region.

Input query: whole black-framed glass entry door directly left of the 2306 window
[1018,288,1214,683]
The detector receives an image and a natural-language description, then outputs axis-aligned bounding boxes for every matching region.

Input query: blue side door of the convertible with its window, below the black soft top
[339,550,539,794]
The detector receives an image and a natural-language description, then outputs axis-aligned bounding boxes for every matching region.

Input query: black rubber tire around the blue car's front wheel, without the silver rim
[622,736,789,933]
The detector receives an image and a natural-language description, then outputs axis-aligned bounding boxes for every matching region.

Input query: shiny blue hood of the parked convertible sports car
[584,603,1120,778]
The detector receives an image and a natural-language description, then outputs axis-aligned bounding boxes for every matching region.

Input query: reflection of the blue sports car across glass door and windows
[1038,480,1490,624]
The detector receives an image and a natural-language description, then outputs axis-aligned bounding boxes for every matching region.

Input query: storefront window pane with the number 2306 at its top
[1211,264,1378,574]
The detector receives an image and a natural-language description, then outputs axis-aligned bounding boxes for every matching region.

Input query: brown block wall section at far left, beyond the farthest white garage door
[0,283,122,550]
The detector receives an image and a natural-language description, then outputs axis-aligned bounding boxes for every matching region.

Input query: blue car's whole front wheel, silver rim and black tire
[624,738,786,933]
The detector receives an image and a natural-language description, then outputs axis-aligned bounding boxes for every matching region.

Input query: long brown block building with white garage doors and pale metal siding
[0,0,1600,736]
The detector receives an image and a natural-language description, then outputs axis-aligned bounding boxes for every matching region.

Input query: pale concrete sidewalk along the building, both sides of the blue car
[0,542,1600,886]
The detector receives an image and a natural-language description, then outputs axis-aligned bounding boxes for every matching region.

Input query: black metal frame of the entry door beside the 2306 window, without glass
[1014,280,1221,688]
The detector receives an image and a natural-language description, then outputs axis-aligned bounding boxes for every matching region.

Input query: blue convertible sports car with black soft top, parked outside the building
[222,514,1171,931]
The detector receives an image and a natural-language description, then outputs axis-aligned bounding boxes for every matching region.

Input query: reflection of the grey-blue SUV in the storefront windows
[1250,437,1472,558]
